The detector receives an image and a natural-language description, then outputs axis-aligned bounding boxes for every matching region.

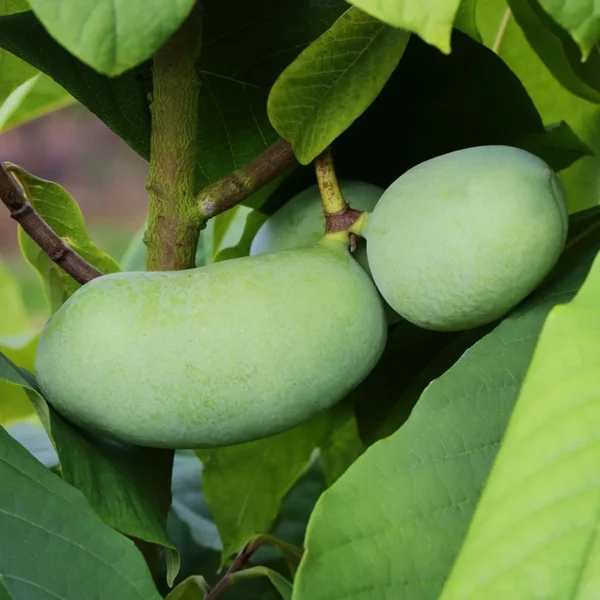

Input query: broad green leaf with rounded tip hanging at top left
[29,0,195,76]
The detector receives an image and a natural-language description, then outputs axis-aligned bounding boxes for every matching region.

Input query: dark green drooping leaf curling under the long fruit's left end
[0,353,179,567]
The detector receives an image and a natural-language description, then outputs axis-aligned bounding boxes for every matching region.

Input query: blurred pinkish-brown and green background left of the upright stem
[0,104,148,322]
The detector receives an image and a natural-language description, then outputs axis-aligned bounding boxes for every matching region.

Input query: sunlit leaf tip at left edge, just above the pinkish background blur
[0,71,74,132]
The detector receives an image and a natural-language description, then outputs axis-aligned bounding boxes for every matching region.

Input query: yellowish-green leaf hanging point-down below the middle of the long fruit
[196,415,326,561]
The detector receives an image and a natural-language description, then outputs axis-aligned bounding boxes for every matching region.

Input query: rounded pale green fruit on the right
[366,146,568,331]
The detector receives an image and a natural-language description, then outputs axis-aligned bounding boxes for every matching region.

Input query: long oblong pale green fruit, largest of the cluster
[35,238,387,448]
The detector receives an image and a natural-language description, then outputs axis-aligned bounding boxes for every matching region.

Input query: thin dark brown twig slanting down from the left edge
[0,163,103,284]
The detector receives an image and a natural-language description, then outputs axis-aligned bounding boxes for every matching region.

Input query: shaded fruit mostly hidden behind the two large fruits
[250,180,400,323]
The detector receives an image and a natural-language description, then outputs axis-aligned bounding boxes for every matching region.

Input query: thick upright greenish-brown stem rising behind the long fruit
[144,2,202,271]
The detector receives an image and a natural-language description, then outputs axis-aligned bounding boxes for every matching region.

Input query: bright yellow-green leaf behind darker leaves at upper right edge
[477,0,600,212]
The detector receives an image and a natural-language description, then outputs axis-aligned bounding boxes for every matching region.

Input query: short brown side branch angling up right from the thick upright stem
[197,140,298,221]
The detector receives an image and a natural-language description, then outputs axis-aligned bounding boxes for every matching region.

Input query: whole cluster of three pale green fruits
[36,146,567,448]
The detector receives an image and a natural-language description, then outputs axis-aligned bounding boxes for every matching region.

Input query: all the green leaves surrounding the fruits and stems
[0,0,600,600]
